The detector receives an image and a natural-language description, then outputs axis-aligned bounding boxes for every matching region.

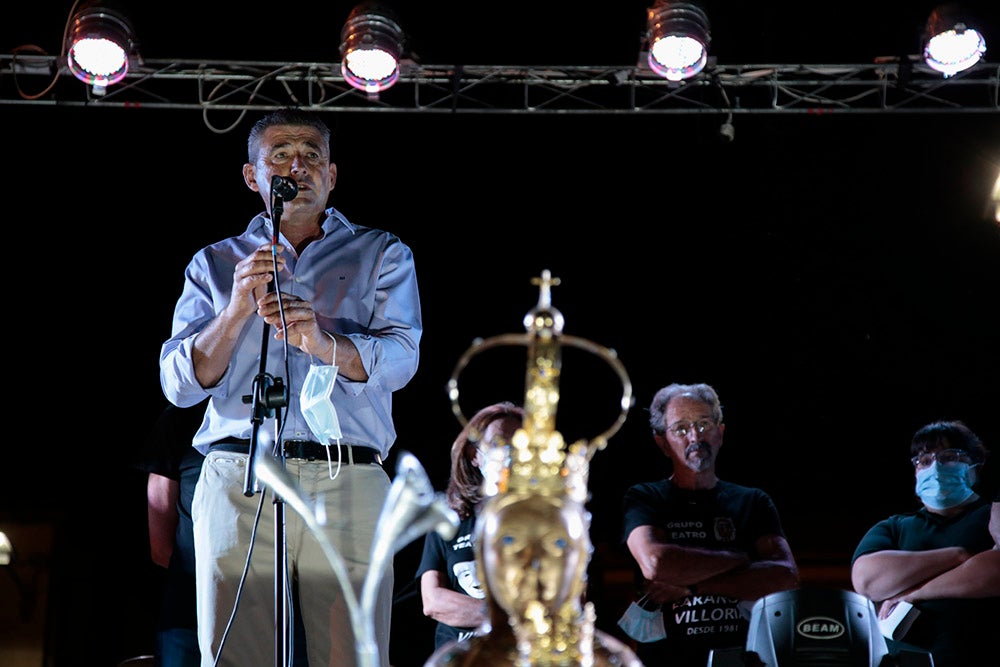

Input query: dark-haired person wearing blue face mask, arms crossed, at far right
[851,421,1000,667]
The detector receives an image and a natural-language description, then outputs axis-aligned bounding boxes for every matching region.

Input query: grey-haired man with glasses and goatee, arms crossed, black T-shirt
[620,384,799,667]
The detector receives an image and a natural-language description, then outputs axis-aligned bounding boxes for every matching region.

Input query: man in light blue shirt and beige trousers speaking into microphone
[160,108,423,667]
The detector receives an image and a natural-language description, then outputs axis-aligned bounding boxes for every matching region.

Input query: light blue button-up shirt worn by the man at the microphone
[160,208,423,459]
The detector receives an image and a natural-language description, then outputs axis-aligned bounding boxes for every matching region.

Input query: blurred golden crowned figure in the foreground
[426,270,641,667]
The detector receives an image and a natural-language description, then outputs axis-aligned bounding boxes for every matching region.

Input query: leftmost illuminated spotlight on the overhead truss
[66,3,134,95]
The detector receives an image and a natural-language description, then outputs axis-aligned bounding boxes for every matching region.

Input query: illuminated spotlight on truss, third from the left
[646,0,712,81]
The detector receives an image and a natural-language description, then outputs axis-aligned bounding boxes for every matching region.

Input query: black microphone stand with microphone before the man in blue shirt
[243,176,298,667]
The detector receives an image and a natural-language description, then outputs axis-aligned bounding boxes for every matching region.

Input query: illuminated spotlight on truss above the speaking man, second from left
[340,2,404,96]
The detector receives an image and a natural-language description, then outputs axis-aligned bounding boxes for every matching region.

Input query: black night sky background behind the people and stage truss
[0,1,1000,665]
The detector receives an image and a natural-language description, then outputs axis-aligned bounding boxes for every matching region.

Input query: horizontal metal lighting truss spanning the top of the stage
[0,53,1000,121]
